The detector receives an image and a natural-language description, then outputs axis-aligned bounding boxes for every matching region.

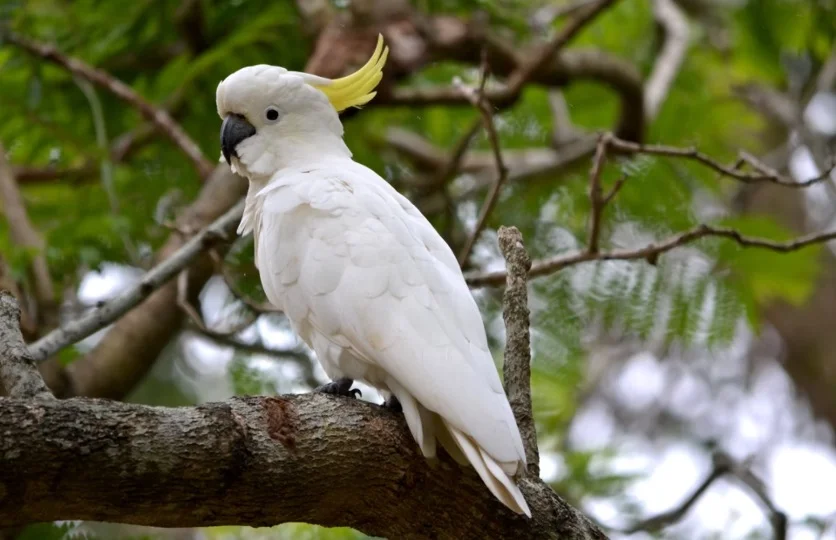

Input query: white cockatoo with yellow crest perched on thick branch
[216,37,531,517]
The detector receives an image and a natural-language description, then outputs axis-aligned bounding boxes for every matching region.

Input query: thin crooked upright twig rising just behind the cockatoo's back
[459,57,508,267]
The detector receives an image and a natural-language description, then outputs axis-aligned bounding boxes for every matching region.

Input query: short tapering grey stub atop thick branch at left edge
[0,291,52,398]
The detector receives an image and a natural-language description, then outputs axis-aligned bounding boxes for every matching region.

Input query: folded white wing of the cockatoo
[257,162,525,463]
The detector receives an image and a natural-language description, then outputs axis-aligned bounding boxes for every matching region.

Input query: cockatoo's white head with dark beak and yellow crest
[216,36,389,176]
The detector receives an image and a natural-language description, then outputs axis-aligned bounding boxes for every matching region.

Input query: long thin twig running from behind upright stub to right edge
[465,224,836,287]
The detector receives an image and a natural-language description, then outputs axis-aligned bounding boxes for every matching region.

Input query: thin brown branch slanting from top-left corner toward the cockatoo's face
[2,32,215,179]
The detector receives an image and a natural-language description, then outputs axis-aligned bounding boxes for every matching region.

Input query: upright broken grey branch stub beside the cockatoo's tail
[499,227,540,478]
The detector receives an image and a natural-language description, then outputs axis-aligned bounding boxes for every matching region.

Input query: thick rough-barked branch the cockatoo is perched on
[0,394,606,540]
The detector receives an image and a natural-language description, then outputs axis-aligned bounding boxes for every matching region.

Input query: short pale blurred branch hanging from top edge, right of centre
[644,0,689,119]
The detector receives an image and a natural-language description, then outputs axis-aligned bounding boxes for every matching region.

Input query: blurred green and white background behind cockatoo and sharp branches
[0,0,836,540]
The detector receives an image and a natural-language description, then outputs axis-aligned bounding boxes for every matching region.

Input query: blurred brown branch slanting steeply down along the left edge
[0,144,56,324]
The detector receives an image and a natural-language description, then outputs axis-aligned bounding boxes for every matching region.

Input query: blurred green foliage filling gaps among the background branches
[0,0,836,539]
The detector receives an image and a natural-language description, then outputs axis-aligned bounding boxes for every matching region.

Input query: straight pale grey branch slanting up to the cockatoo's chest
[29,201,244,362]
